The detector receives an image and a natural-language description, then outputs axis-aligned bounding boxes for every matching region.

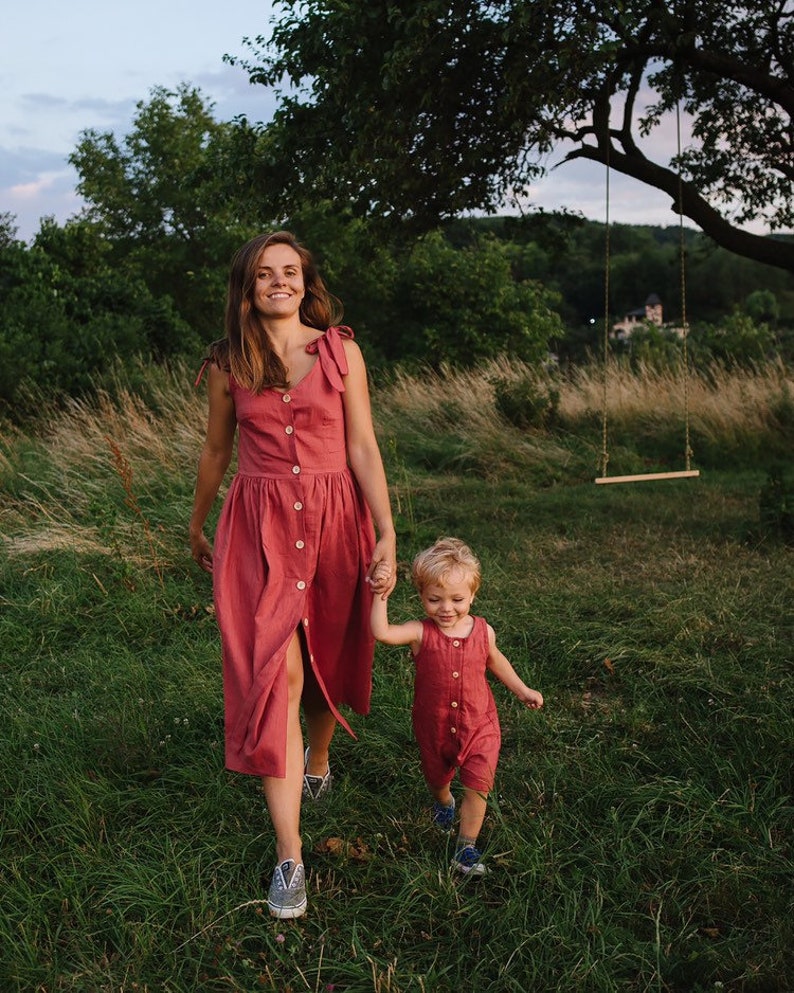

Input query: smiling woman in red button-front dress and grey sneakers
[190,231,396,917]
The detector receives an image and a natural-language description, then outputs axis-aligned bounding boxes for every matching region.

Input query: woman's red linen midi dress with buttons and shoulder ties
[213,328,375,777]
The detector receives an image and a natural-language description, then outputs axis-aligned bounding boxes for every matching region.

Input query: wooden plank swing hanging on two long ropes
[595,107,700,483]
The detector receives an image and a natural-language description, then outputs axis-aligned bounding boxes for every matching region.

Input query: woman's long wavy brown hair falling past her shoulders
[225,231,342,393]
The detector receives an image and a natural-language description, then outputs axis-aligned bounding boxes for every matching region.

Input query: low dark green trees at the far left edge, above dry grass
[0,218,195,419]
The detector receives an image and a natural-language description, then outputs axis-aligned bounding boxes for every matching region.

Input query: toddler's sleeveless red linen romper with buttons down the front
[412,615,502,792]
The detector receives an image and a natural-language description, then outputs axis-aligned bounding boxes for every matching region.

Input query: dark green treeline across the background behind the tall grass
[0,204,794,421]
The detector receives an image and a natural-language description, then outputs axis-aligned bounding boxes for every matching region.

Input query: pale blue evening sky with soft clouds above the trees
[0,0,744,241]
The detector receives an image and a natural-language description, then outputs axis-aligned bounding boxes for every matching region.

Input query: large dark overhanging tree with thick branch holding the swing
[234,0,794,271]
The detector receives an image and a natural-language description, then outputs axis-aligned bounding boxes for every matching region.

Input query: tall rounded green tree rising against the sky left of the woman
[69,85,278,337]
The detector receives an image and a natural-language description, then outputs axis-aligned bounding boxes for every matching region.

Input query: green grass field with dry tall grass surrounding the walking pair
[0,363,794,993]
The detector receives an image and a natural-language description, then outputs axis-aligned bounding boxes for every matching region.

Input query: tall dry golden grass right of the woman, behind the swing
[377,359,794,484]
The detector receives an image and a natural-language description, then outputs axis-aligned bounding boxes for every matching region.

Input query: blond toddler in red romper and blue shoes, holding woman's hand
[371,538,543,875]
